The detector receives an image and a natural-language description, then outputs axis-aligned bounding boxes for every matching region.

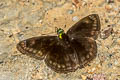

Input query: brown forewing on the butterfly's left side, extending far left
[17,36,57,59]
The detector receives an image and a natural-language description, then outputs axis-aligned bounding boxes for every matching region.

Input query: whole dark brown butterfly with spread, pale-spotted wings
[17,14,100,73]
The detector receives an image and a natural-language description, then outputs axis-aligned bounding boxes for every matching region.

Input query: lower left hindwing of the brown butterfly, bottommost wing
[45,38,79,73]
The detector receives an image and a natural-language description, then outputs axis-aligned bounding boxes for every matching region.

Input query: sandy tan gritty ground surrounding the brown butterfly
[0,0,120,80]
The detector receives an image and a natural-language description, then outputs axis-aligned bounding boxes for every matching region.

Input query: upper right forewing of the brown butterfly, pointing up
[67,14,100,39]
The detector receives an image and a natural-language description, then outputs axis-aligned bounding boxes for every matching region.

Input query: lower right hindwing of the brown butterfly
[71,37,97,68]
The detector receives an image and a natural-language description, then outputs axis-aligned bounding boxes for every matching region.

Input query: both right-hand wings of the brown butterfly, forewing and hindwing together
[66,14,100,68]
